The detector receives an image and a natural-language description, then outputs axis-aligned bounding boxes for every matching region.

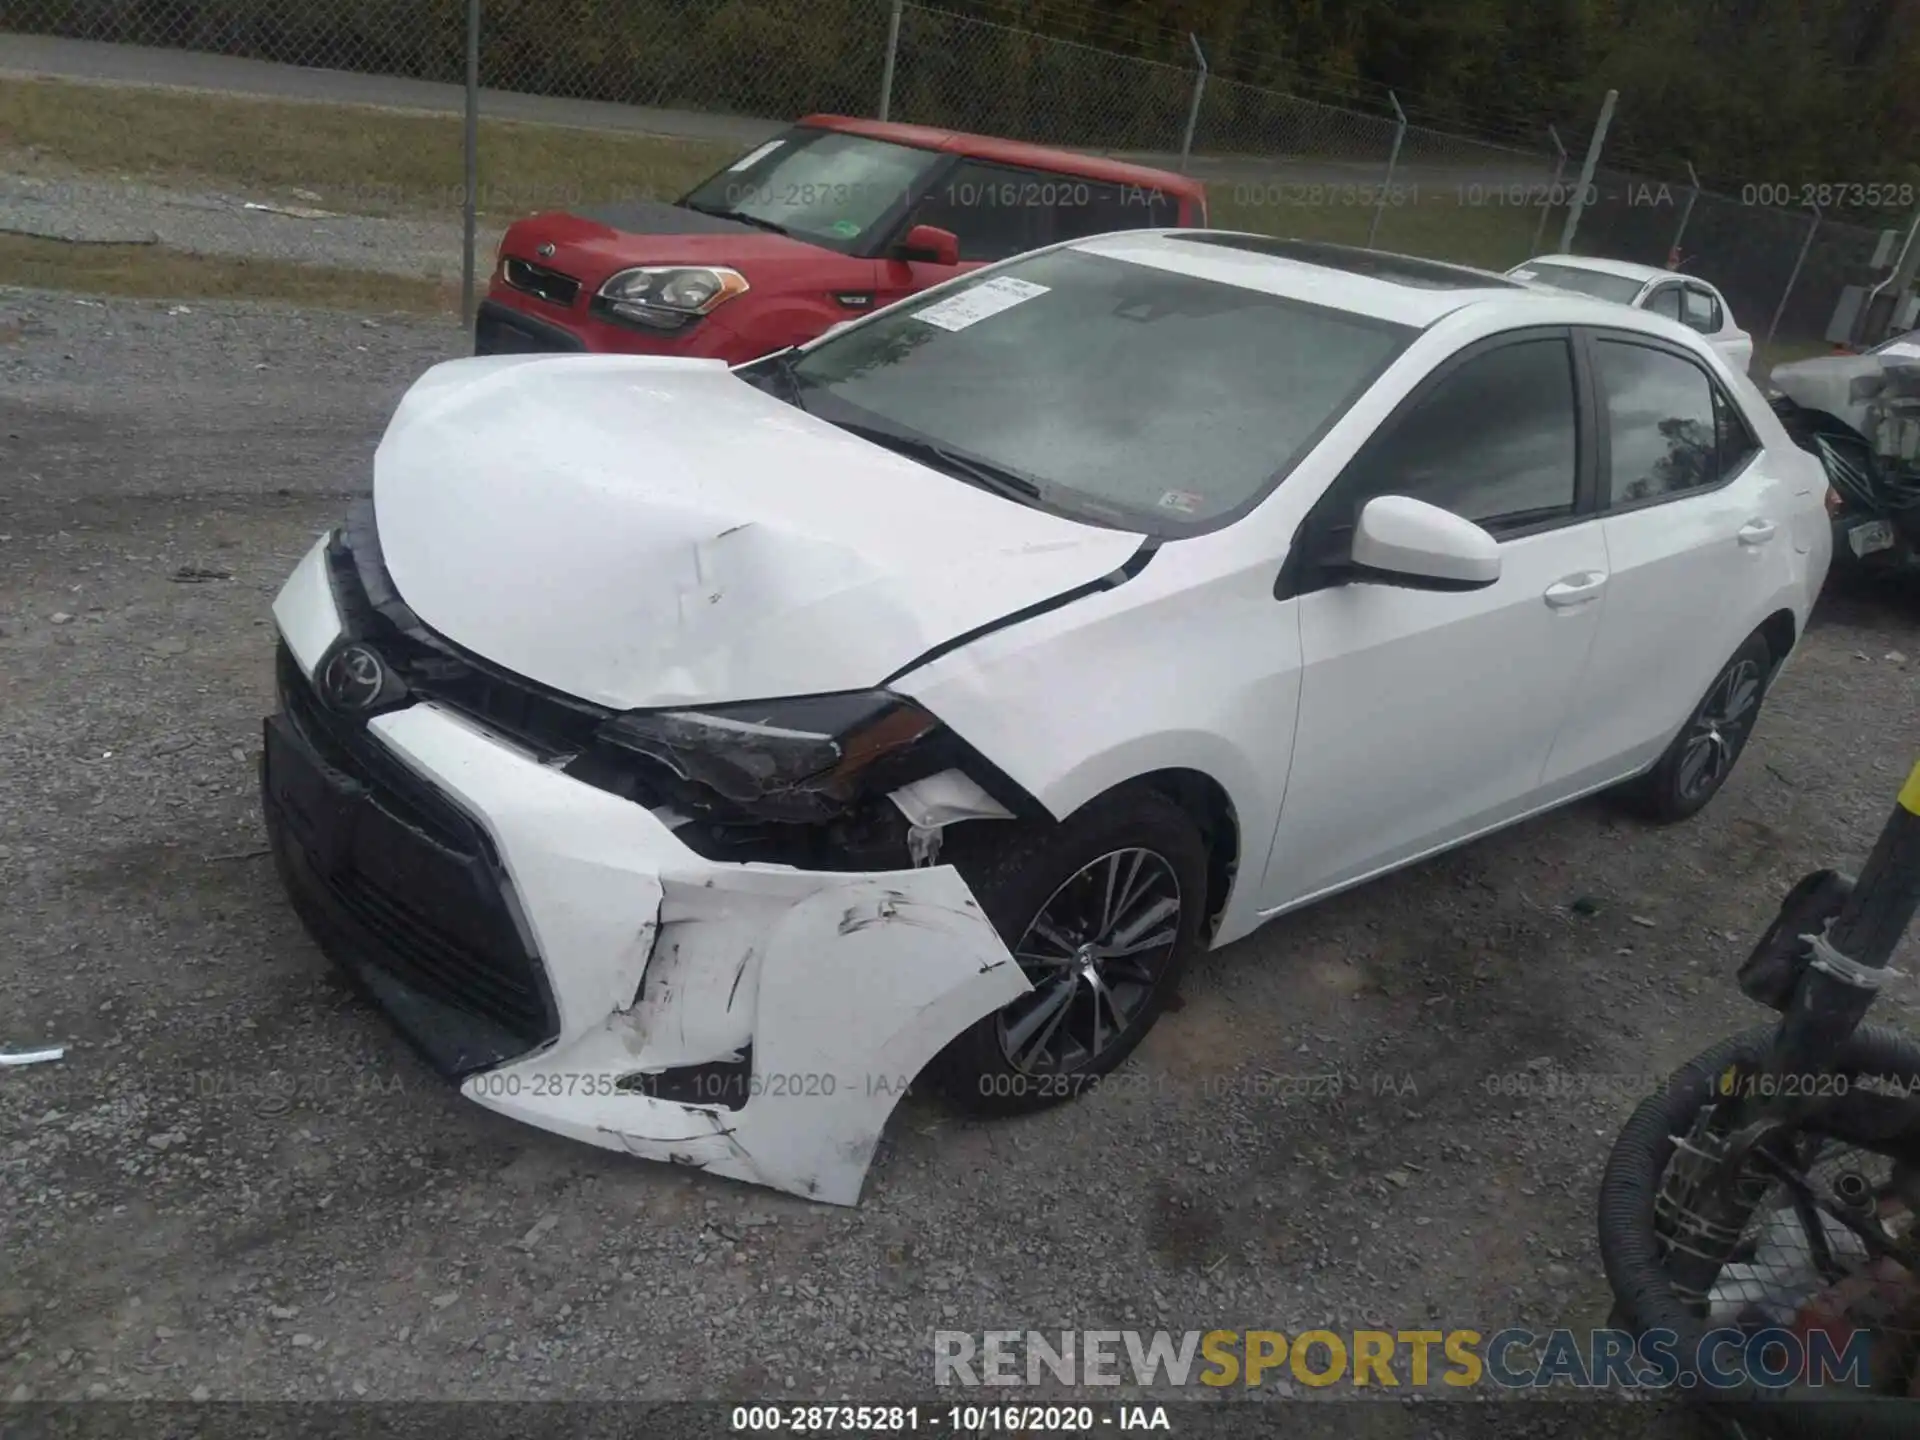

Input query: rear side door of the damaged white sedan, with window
[1548,330,1793,791]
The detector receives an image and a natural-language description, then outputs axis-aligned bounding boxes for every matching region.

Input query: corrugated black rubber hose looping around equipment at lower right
[1599,1025,1920,1440]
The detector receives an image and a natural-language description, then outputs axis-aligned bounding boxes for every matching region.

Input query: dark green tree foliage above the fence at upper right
[1006,0,1920,190]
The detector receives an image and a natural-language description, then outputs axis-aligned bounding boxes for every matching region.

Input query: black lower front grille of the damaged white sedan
[276,643,559,1048]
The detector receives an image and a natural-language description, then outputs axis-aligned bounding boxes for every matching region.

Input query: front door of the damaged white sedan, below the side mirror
[1263,330,1607,910]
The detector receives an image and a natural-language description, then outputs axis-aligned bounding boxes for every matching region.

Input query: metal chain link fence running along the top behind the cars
[0,0,1893,355]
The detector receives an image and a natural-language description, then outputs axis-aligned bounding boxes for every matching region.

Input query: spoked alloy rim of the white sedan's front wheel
[998,849,1181,1075]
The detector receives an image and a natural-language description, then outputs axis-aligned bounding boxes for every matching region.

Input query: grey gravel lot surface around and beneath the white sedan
[0,292,1920,1436]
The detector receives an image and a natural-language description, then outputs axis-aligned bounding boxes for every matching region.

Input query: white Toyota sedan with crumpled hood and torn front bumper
[263,232,1830,1204]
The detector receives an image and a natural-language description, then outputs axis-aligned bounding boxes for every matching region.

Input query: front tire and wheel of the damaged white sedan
[935,787,1208,1116]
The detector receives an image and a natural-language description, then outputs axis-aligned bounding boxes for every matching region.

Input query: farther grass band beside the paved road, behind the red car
[0,81,735,219]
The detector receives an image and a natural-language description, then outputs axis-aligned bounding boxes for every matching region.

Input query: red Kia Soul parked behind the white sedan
[474,115,1208,363]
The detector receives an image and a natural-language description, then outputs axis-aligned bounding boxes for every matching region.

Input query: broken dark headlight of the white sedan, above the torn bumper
[595,689,939,824]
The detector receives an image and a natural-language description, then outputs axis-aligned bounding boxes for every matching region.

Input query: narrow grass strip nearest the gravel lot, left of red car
[0,234,461,315]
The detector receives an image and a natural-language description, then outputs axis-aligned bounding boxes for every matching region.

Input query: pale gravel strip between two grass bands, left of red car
[0,175,480,278]
